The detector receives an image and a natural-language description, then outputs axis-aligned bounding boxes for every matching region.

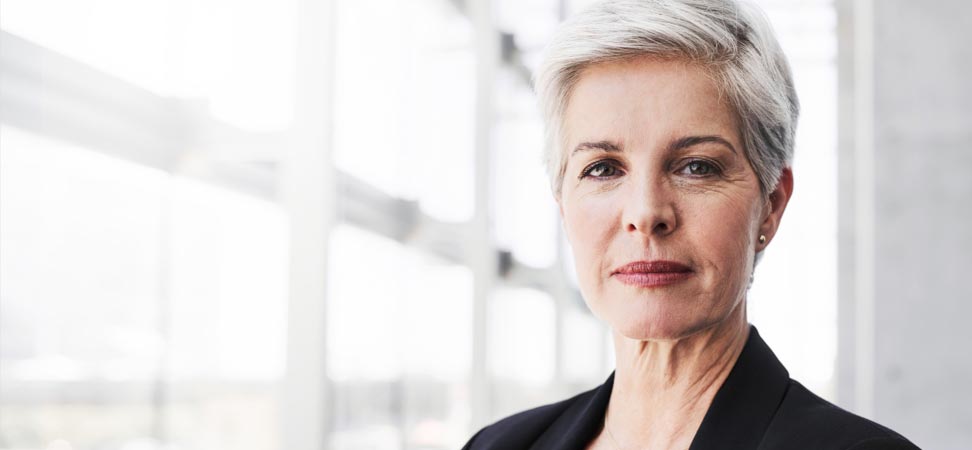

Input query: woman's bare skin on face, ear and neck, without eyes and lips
[557,58,792,449]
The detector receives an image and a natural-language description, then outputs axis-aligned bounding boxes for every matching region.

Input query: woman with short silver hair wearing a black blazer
[465,0,916,450]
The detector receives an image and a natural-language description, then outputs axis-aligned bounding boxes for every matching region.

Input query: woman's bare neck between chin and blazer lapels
[604,301,749,449]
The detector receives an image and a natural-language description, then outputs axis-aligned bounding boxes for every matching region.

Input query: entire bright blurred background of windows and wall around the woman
[0,0,972,450]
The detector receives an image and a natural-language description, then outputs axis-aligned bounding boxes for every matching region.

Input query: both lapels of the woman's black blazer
[531,325,790,450]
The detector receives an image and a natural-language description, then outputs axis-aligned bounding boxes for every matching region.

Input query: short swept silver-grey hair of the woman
[534,0,800,198]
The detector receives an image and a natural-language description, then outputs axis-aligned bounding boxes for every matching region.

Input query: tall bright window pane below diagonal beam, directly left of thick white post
[164,177,288,450]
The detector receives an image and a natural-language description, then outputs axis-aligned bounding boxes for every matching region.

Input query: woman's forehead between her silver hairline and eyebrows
[564,58,738,149]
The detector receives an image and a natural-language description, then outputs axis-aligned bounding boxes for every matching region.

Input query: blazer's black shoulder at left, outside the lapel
[462,389,597,450]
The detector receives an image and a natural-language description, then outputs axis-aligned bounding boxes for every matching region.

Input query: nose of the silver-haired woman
[622,180,678,237]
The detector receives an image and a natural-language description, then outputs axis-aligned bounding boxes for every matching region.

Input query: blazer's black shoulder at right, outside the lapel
[760,380,918,450]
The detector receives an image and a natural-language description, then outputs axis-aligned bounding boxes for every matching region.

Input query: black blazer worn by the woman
[463,326,918,450]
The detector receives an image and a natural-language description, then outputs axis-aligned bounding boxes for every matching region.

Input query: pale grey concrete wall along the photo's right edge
[838,0,972,450]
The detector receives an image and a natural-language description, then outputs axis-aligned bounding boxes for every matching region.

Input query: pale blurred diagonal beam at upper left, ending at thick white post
[0,31,286,199]
